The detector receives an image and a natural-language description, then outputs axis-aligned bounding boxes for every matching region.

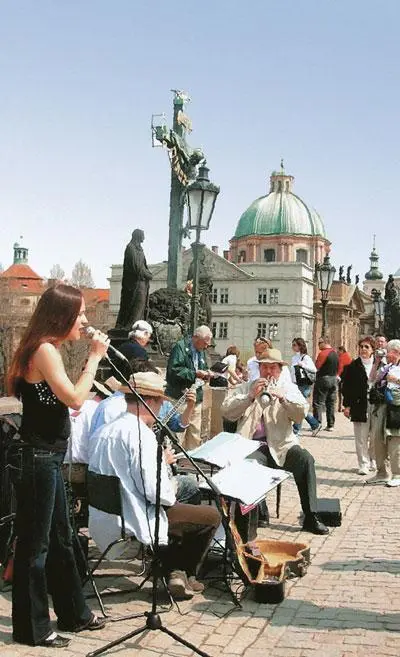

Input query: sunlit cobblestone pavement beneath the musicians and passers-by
[0,416,400,657]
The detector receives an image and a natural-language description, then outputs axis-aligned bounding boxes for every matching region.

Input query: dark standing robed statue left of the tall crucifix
[116,228,152,330]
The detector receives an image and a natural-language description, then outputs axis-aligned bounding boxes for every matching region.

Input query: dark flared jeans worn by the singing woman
[12,447,91,645]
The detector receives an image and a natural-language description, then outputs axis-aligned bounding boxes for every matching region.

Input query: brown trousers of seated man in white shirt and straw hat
[161,502,221,576]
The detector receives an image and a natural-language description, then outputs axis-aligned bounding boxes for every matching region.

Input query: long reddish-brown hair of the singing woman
[8,283,82,395]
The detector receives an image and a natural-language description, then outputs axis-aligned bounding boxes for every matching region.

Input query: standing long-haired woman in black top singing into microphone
[9,284,108,648]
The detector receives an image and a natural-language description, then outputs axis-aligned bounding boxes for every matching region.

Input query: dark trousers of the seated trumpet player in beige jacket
[250,445,317,515]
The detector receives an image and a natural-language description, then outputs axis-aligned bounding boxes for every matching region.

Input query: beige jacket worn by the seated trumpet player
[221,381,308,466]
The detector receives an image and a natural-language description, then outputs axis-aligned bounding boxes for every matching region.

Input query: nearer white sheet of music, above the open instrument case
[200,460,290,505]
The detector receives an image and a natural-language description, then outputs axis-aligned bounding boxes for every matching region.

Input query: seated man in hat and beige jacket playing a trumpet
[221,349,329,534]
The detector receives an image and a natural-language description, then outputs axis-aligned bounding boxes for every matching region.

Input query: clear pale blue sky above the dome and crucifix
[0,0,400,286]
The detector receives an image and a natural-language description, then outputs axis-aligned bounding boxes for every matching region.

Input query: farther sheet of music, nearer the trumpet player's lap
[188,431,260,468]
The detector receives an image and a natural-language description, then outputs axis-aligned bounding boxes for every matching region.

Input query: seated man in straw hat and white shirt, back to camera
[89,372,220,599]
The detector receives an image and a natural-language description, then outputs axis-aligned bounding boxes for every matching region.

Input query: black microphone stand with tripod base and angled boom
[86,355,241,657]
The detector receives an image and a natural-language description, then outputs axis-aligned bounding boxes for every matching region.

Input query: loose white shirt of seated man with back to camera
[89,413,176,550]
